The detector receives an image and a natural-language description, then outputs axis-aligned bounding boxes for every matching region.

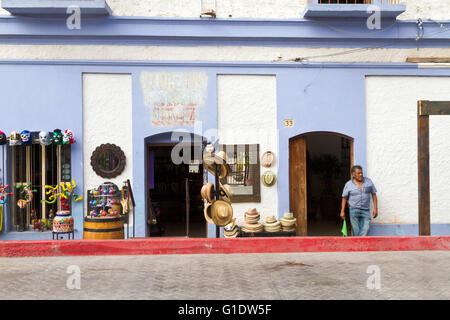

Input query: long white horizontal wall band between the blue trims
[0,45,450,62]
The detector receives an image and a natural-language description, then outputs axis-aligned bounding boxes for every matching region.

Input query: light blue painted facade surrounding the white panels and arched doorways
[0,1,450,240]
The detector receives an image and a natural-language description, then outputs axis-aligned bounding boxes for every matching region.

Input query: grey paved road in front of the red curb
[0,251,450,300]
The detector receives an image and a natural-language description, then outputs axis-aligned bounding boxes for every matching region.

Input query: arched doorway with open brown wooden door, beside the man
[289,132,353,236]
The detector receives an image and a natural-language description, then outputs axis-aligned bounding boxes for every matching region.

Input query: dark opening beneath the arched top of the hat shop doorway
[147,144,206,238]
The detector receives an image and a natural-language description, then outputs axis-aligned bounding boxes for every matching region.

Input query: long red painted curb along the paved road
[0,236,450,257]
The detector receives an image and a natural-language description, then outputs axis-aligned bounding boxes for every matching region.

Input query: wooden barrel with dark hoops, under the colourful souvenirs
[83,217,125,239]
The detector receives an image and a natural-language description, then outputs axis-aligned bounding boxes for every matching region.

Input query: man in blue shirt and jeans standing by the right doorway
[340,166,378,237]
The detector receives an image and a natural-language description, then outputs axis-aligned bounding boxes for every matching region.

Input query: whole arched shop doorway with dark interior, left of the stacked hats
[145,132,207,238]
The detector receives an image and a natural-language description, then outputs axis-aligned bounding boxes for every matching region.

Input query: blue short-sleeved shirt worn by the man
[342,177,377,210]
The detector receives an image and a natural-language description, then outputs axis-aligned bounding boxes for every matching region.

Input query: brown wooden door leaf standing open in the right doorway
[289,137,307,236]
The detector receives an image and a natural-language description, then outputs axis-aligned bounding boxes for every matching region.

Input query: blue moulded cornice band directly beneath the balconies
[0,16,450,48]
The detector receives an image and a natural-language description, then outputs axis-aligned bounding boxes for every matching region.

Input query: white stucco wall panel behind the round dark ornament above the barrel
[83,74,133,214]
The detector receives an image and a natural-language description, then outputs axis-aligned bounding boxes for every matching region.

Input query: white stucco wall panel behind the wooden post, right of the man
[366,77,450,223]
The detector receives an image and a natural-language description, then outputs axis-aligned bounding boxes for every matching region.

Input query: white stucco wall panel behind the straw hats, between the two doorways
[217,75,282,225]
